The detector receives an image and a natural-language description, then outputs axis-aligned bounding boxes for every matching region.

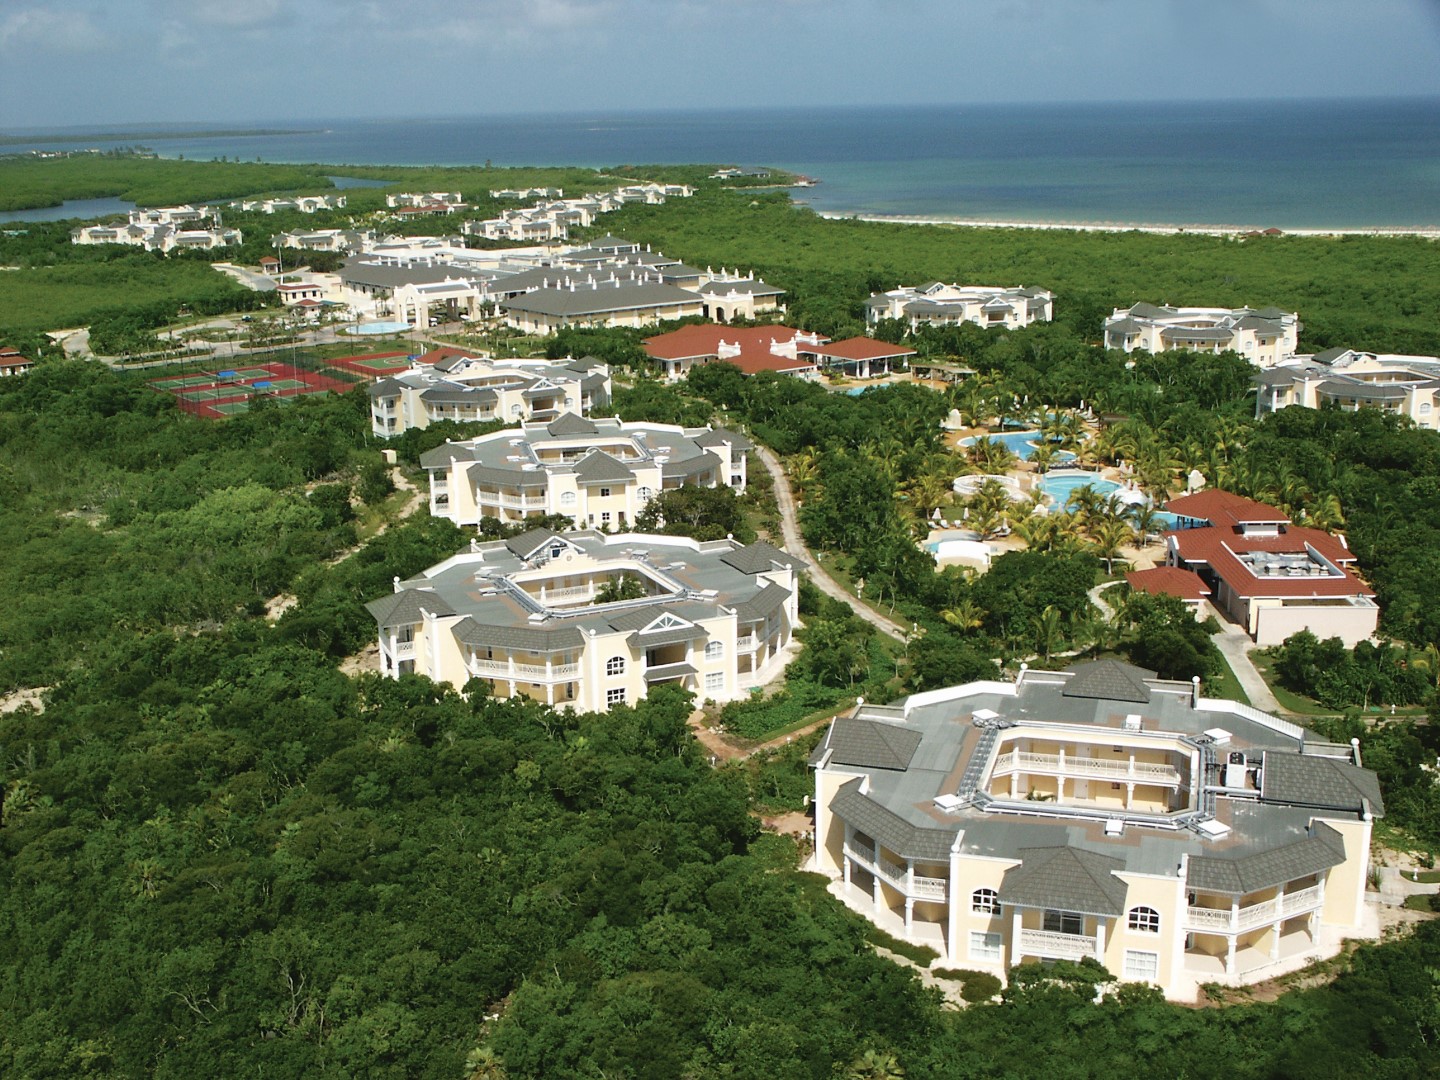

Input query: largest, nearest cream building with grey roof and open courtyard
[811,660,1384,1001]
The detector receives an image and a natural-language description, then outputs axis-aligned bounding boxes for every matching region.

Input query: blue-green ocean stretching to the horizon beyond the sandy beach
[7,99,1440,229]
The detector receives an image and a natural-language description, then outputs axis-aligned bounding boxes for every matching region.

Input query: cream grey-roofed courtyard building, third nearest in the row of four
[420,413,750,531]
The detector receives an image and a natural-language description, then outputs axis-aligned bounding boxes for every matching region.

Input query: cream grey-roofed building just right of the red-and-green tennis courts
[370,348,611,438]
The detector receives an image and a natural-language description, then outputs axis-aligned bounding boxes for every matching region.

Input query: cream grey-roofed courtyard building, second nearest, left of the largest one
[366,528,804,711]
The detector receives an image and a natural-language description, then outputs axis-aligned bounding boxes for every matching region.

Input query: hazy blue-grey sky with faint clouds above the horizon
[0,0,1440,131]
